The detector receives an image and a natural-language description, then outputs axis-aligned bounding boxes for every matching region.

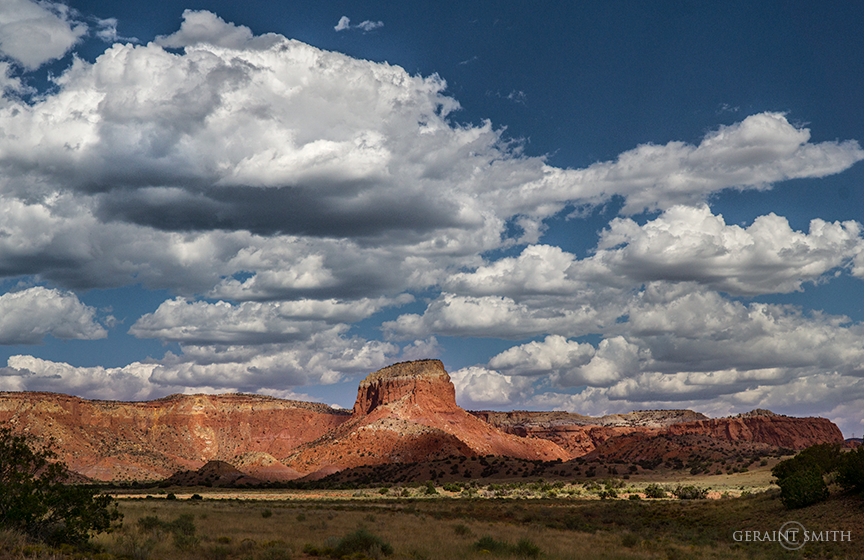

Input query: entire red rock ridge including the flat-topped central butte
[0,360,843,481]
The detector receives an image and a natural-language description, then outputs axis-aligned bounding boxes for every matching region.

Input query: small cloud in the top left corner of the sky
[0,0,87,70]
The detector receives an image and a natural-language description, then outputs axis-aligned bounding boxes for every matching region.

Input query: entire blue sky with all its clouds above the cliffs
[0,0,864,437]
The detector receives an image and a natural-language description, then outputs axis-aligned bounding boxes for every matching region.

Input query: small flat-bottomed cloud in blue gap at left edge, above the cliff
[0,286,108,344]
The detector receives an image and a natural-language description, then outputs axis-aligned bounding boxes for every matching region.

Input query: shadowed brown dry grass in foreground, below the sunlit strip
[84,488,864,560]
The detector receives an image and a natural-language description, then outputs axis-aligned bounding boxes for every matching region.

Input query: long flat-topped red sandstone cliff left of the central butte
[0,393,350,480]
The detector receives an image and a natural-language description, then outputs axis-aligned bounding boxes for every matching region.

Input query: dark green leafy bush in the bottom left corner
[0,427,121,544]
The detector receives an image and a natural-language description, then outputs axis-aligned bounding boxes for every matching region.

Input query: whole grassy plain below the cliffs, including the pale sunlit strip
[0,470,864,560]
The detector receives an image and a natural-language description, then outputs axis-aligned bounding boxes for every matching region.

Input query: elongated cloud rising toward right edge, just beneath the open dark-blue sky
[548,113,864,214]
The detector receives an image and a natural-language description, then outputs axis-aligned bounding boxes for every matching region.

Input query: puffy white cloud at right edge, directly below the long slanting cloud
[586,205,864,295]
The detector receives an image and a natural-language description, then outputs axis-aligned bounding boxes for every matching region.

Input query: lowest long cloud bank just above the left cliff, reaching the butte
[0,326,399,400]
